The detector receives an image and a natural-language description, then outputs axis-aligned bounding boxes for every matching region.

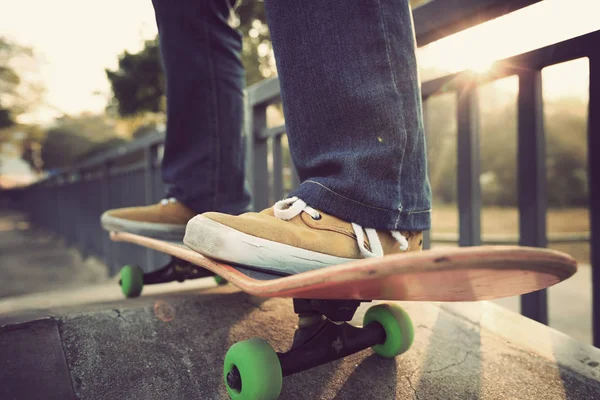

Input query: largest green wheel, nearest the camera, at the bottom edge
[223,338,283,400]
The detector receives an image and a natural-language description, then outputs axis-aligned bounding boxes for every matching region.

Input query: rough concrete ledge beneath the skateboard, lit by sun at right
[0,286,600,400]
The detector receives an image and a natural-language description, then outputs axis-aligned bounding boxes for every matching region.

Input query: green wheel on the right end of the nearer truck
[363,304,415,358]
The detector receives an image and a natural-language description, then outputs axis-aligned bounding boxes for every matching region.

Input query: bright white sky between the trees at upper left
[0,0,157,120]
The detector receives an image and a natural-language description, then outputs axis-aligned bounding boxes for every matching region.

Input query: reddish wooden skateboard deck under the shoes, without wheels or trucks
[111,232,577,302]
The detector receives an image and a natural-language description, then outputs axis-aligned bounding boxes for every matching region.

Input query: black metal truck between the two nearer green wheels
[226,299,386,391]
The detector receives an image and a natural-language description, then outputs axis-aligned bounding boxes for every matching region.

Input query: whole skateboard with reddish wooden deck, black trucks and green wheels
[110,232,577,400]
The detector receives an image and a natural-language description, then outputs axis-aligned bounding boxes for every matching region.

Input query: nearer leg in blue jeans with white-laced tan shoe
[184,0,431,273]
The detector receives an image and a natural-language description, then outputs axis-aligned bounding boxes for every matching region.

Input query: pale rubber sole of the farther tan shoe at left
[100,213,185,242]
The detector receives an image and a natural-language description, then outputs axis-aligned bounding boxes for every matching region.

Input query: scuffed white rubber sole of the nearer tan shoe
[183,215,354,275]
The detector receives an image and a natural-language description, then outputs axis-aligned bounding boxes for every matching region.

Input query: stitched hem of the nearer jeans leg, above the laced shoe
[290,181,431,231]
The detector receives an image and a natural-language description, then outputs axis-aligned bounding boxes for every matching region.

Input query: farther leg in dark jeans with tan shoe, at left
[102,0,250,240]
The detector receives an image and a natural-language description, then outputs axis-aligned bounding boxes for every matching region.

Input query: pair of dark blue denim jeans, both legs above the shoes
[154,0,431,230]
